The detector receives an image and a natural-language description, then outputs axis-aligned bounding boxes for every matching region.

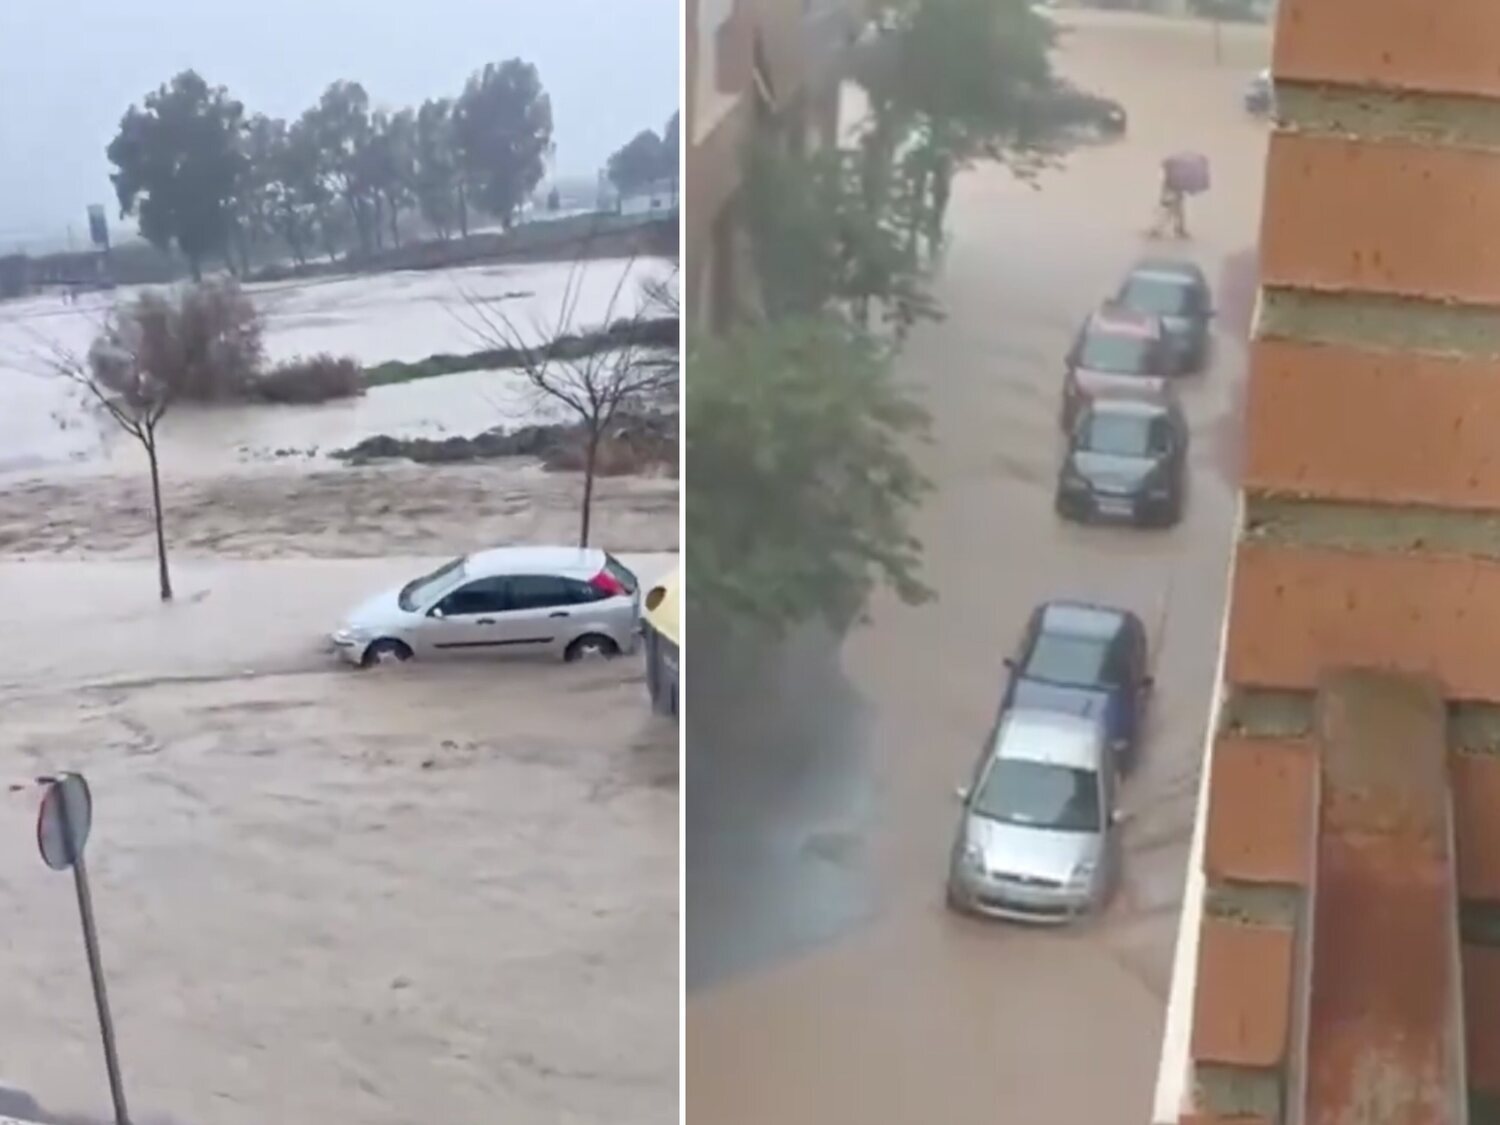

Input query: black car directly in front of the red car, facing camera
[1056,399,1188,527]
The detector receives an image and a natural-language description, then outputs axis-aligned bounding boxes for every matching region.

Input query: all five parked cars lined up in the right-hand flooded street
[947,260,1214,924]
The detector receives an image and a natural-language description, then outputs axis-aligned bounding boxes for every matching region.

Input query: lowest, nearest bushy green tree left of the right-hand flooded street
[687,318,932,633]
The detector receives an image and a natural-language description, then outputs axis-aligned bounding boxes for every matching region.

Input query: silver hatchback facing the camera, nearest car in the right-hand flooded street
[948,710,1121,924]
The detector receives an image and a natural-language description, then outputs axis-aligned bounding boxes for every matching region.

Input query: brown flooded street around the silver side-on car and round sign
[0,545,678,1125]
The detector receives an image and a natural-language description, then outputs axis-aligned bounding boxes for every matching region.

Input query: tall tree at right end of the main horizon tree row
[455,59,552,228]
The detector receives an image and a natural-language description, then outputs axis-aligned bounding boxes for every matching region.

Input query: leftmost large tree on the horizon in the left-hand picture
[107,71,245,279]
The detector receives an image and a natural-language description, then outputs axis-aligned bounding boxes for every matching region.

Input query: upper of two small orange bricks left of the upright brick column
[1203,738,1317,887]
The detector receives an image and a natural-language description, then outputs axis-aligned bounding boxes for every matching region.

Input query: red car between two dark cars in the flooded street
[1061,305,1173,431]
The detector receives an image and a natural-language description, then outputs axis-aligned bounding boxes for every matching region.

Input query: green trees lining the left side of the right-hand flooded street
[687,0,1112,636]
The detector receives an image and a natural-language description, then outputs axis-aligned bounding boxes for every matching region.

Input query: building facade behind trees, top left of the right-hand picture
[684,0,864,332]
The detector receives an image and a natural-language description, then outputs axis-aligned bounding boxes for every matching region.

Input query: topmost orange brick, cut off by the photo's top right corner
[1272,0,1500,98]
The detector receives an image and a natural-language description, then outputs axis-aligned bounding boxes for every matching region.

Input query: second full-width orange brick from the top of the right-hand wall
[1260,132,1500,305]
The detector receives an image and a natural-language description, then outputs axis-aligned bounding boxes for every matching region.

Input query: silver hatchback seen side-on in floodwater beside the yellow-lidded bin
[332,548,641,668]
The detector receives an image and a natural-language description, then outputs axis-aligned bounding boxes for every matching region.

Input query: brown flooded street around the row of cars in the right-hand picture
[687,14,1269,1125]
